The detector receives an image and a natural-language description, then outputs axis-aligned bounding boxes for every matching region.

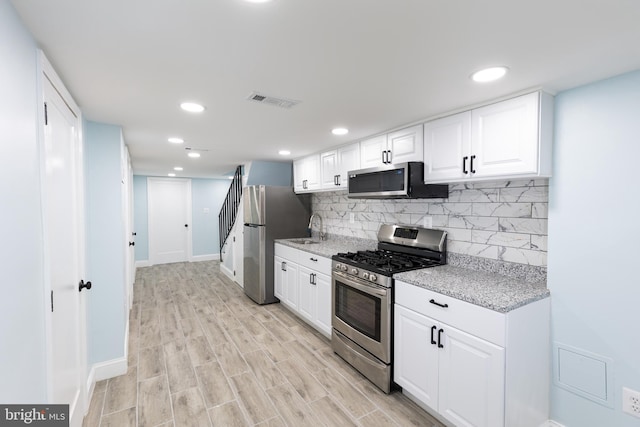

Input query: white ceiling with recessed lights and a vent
[8,0,640,177]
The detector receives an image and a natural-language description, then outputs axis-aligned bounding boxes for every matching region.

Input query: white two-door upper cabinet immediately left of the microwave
[320,144,360,190]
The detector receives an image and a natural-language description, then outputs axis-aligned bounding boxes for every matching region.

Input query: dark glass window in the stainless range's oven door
[334,280,381,342]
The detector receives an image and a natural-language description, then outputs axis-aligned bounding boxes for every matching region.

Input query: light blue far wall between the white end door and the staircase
[191,179,231,256]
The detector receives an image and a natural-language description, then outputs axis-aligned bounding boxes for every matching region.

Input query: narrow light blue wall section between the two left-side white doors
[84,121,127,366]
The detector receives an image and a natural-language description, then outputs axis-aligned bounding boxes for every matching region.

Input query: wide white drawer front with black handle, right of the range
[394,280,506,347]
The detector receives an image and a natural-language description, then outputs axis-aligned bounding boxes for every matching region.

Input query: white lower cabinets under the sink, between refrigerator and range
[274,244,331,337]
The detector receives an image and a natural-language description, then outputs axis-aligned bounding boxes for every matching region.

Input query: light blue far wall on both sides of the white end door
[133,175,231,261]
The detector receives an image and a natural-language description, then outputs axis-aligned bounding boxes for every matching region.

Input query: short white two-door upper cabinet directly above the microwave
[360,125,424,168]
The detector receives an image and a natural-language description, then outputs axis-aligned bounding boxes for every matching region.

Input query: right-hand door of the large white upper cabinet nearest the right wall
[470,92,539,177]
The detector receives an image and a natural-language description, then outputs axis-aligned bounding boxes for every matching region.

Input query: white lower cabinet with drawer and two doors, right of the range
[394,281,550,427]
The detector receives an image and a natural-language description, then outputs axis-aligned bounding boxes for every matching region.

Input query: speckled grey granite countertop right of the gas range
[393,265,550,313]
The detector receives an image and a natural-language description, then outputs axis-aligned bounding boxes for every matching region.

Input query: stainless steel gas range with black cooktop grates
[331,224,447,393]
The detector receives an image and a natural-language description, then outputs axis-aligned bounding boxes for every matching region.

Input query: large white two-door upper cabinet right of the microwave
[424,92,553,182]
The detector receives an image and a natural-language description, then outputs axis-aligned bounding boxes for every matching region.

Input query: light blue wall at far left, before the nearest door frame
[0,0,46,404]
